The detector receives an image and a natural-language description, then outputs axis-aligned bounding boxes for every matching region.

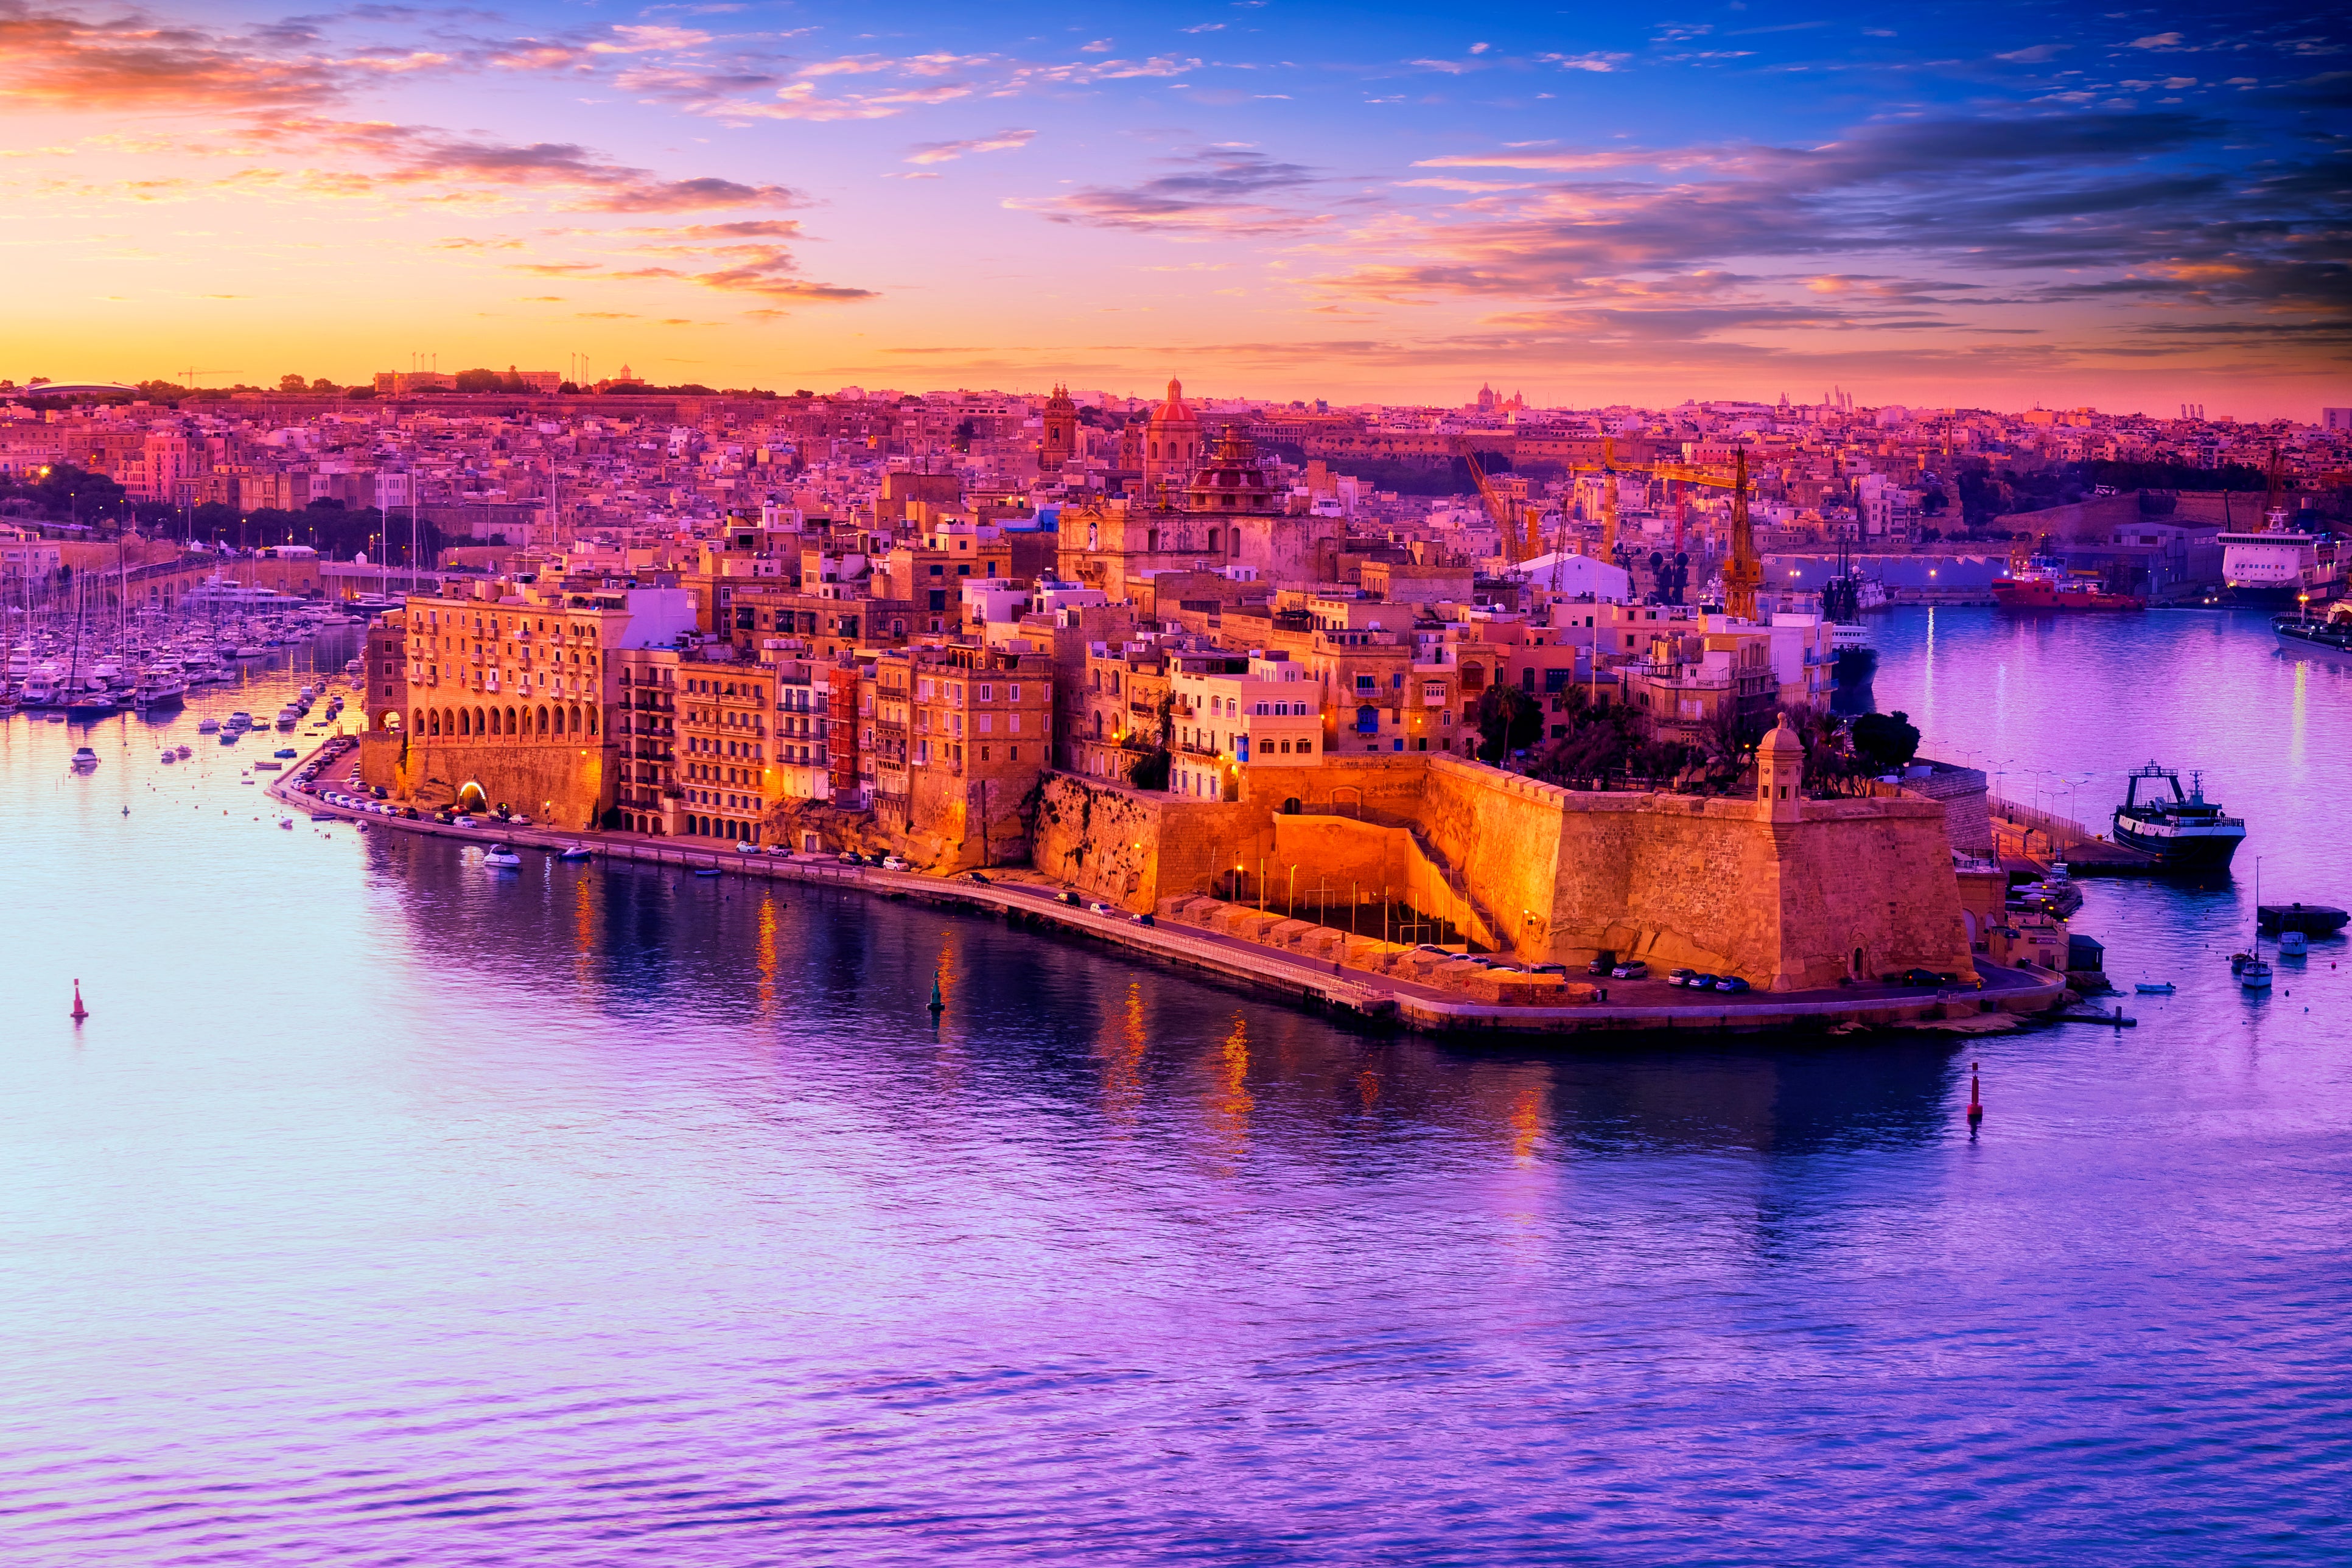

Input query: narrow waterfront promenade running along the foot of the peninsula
[284,750,2065,1034]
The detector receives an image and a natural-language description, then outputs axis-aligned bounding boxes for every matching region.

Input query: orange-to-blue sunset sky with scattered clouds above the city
[0,0,2352,418]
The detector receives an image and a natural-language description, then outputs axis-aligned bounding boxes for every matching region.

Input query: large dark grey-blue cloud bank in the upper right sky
[1307,111,2352,364]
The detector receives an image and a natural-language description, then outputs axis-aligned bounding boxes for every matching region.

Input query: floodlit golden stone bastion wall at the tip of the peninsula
[1035,757,1973,990]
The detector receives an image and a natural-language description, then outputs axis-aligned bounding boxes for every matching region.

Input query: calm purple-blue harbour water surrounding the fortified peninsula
[0,611,2352,1566]
